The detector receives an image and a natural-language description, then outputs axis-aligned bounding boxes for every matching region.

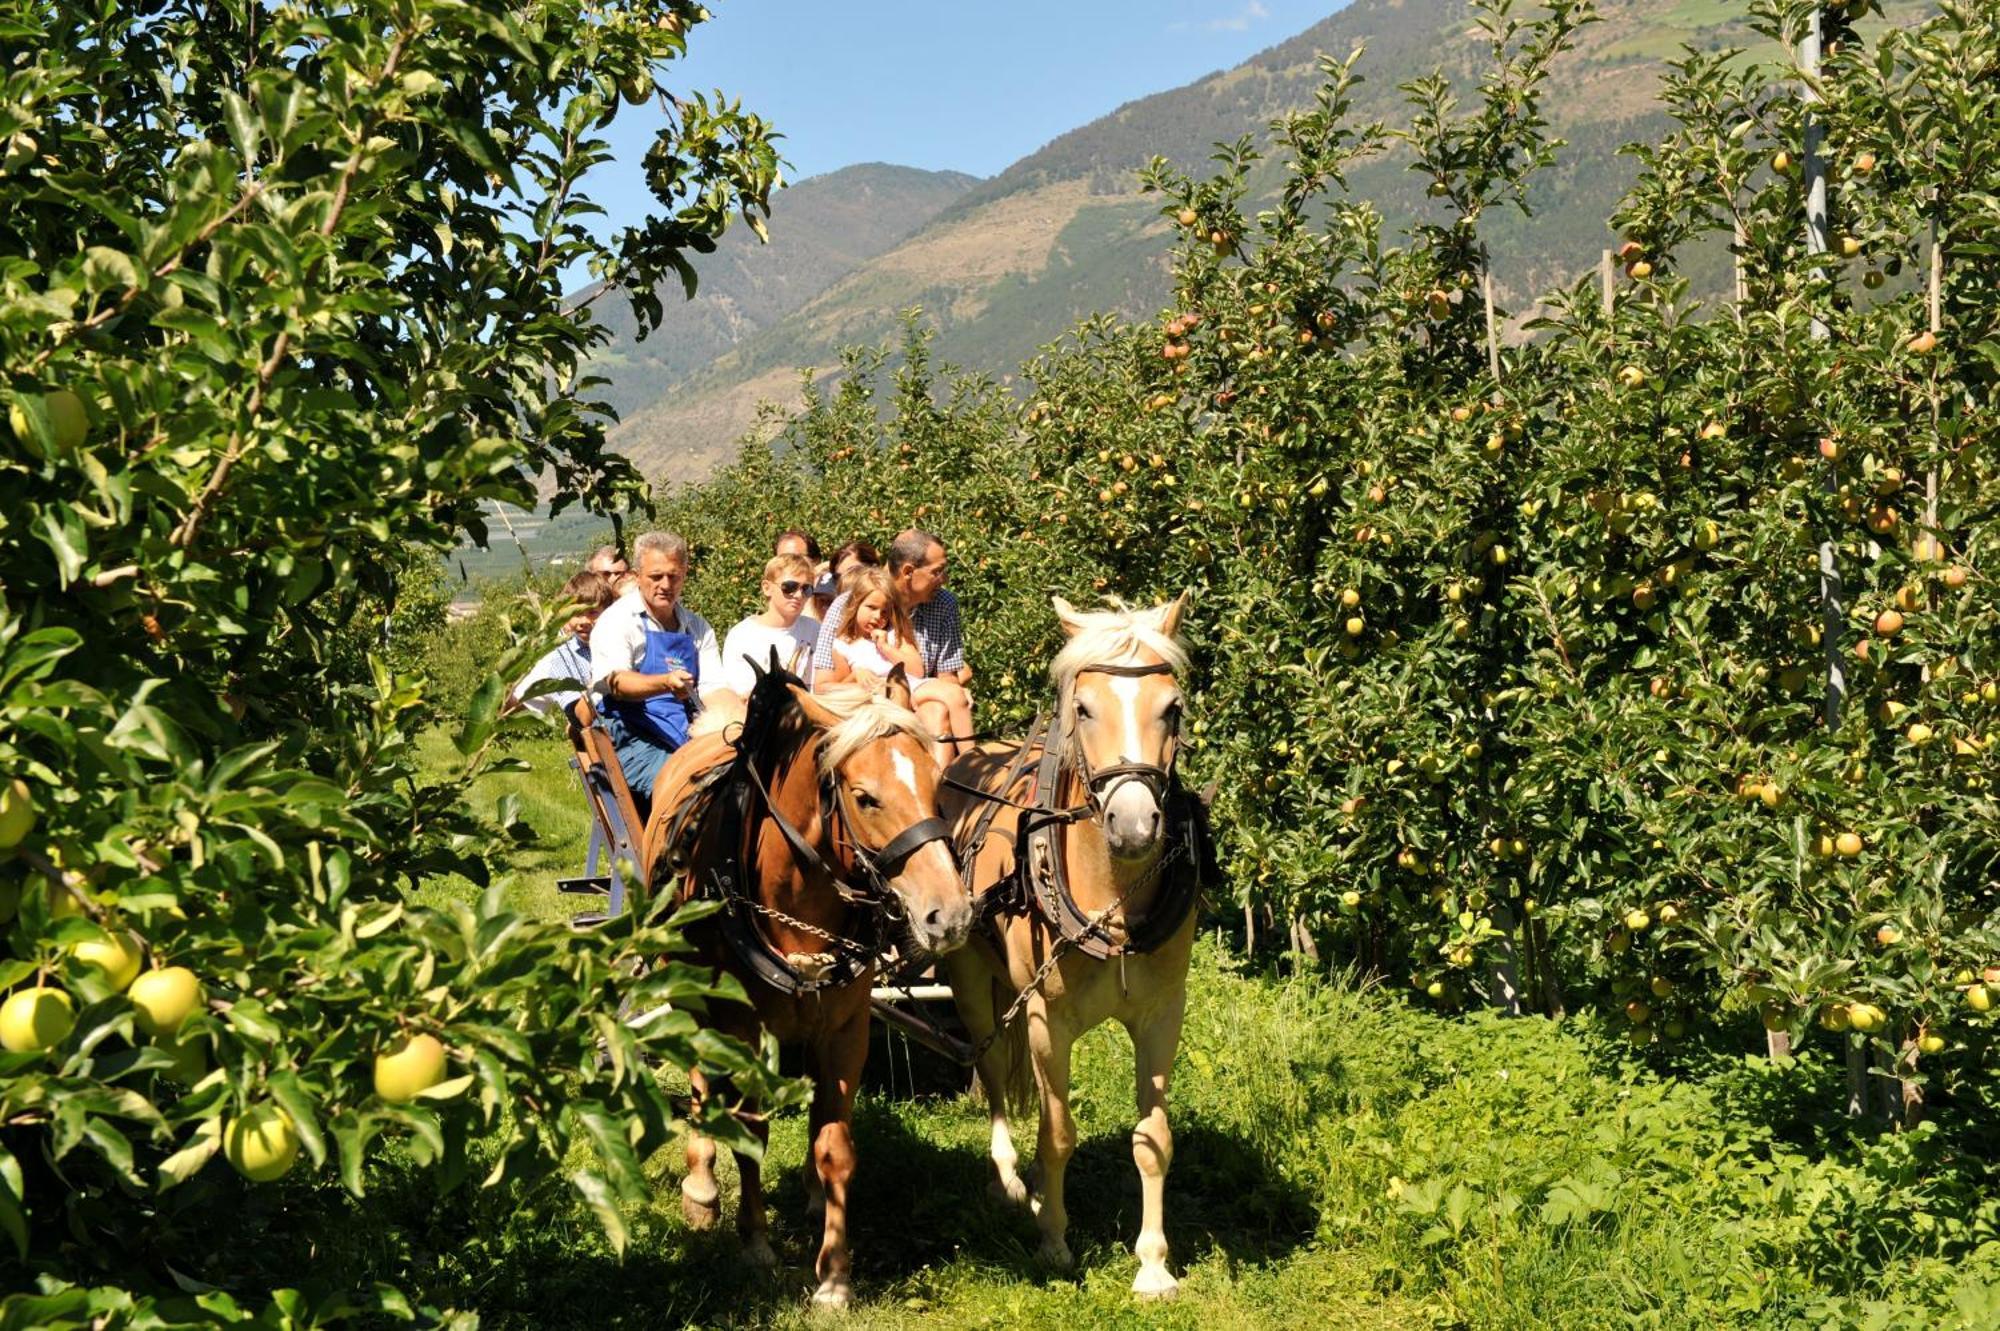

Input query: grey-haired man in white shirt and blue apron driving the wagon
[590,532,722,817]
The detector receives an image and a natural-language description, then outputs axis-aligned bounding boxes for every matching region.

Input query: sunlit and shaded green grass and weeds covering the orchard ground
[378,739,2000,1331]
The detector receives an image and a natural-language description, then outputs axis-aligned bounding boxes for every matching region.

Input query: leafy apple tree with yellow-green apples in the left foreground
[0,0,804,1325]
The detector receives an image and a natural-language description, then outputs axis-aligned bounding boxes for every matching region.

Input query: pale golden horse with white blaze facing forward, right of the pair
[944,598,1206,1297]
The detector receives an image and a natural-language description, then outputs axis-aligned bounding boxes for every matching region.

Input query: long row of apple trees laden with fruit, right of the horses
[660,2,2000,1115]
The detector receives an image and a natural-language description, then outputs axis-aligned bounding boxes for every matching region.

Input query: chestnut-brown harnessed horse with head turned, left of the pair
[646,671,972,1307]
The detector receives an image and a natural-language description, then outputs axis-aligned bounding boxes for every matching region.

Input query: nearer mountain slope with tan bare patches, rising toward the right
[612,0,1918,480]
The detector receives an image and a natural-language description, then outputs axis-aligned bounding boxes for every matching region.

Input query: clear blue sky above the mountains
[586,0,1346,242]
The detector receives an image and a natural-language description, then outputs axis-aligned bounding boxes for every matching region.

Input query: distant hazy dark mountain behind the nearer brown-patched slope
[578,162,978,414]
